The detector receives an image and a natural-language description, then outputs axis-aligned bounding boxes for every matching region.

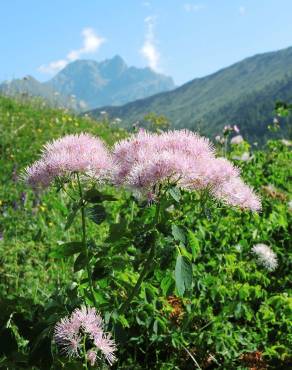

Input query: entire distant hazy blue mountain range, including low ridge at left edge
[0,56,175,110]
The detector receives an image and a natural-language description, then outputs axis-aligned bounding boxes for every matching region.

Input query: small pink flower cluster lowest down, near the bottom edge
[54,306,116,366]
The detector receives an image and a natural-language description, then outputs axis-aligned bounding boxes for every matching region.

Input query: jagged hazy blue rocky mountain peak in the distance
[46,55,174,108]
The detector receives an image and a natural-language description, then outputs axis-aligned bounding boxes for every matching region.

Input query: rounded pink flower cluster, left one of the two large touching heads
[25,133,111,188]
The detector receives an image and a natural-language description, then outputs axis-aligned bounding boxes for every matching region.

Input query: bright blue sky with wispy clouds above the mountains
[0,0,292,85]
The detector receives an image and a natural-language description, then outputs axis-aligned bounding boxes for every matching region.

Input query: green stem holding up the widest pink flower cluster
[119,201,160,314]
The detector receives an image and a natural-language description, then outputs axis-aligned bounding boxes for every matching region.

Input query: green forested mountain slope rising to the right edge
[91,47,292,139]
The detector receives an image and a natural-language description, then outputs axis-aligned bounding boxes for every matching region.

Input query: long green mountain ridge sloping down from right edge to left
[89,47,292,140]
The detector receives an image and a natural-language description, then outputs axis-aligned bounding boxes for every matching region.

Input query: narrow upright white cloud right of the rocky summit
[140,16,160,71]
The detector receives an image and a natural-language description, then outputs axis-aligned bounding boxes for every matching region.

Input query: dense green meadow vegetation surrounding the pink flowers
[0,98,292,370]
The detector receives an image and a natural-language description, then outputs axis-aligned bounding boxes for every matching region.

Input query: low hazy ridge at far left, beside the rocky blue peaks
[0,76,83,111]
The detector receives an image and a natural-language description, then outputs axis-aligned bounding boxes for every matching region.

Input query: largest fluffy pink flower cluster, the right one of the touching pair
[113,130,261,211]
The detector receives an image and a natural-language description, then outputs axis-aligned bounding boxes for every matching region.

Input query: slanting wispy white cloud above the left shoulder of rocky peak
[38,28,105,74]
